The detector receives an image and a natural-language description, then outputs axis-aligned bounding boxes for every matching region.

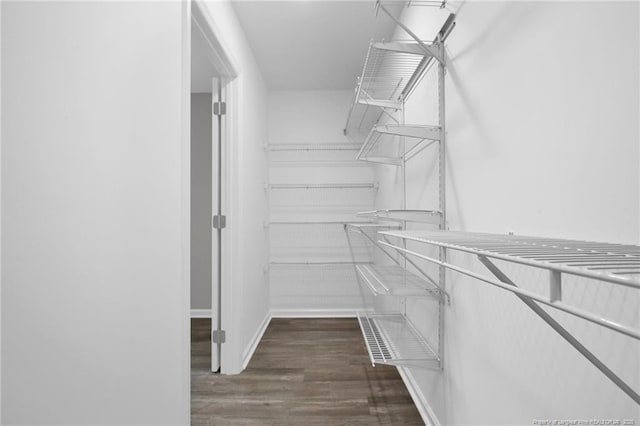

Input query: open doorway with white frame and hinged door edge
[190,1,235,372]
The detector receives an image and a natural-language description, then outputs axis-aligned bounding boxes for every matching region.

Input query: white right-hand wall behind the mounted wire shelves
[378,2,640,424]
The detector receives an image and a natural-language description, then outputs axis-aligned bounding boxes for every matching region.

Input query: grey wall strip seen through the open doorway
[191,93,213,309]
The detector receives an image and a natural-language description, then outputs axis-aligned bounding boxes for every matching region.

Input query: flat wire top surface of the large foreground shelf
[384,231,640,288]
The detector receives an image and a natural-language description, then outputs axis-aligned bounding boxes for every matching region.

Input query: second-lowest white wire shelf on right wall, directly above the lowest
[356,265,441,299]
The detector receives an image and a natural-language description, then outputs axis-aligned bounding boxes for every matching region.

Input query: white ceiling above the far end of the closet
[232,0,402,90]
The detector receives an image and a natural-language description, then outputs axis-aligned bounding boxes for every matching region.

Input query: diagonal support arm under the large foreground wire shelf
[478,256,640,404]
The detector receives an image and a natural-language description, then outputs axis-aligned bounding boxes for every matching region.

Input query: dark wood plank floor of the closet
[191,319,423,426]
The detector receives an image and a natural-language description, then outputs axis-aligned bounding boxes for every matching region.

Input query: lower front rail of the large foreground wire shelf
[378,241,640,340]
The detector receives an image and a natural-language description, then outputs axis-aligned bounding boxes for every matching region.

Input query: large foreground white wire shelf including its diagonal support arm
[379,231,640,404]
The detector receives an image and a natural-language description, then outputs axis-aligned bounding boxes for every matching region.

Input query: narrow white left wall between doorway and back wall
[201,1,269,374]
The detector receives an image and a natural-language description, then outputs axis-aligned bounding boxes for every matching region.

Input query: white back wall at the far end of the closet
[269,90,376,316]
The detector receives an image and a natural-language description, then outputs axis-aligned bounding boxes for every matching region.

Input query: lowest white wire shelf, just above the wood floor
[357,312,440,369]
